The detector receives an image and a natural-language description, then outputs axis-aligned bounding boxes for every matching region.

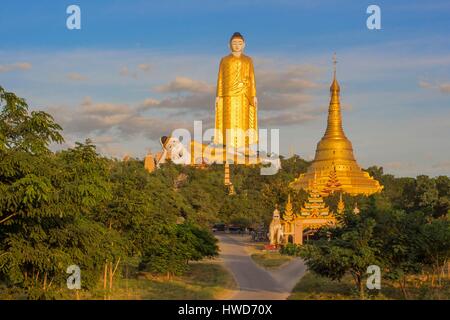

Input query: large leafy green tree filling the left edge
[0,88,115,298]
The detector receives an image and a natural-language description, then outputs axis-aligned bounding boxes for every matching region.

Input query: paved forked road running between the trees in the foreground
[216,234,306,300]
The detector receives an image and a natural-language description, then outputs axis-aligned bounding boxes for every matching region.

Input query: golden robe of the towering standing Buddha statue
[214,54,258,148]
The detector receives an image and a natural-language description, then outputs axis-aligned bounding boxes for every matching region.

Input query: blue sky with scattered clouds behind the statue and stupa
[0,0,450,176]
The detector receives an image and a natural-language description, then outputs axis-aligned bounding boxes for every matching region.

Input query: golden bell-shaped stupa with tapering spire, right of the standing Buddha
[290,57,383,195]
